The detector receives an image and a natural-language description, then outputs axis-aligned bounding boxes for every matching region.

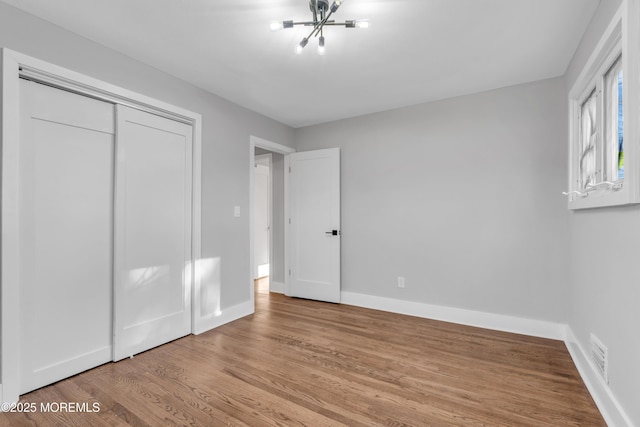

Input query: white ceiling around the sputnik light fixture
[2,0,599,127]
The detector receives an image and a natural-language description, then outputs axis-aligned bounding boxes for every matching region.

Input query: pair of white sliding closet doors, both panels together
[17,79,193,394]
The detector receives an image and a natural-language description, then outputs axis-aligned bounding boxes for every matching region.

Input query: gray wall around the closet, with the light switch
[0,3,293,310]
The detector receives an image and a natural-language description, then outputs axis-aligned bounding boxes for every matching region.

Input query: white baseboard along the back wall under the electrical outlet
[341,292,565,341]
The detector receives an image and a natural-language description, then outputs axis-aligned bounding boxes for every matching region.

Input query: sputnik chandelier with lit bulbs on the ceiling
[271,0,369,55]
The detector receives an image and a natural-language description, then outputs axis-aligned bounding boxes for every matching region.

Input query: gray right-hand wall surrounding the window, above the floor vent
[566,0,640,425]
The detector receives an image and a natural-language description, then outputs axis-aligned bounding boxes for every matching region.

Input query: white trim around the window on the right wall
[566,0,640,209]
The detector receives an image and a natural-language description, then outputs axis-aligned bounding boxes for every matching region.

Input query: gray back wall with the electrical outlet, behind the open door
[295,78,568,322]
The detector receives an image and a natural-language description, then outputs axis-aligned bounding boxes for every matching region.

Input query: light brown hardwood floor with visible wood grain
[0,288,606,427]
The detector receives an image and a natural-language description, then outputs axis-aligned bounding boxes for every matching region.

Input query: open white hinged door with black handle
[287,148,341,302]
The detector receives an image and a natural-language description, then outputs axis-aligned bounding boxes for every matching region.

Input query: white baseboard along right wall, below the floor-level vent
[565,327,633,427]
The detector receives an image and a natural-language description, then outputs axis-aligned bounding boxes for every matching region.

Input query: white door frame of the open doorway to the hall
[249,135,296,311]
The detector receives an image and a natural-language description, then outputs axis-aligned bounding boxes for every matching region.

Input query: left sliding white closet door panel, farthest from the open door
[17,80,115,393]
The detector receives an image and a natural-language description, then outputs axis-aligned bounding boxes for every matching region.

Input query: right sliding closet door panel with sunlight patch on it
[114,105,192,360]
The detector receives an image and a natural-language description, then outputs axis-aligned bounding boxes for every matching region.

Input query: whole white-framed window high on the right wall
[564,1,640,209]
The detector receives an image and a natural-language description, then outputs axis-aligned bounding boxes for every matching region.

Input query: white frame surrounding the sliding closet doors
[0,48,202,403]
